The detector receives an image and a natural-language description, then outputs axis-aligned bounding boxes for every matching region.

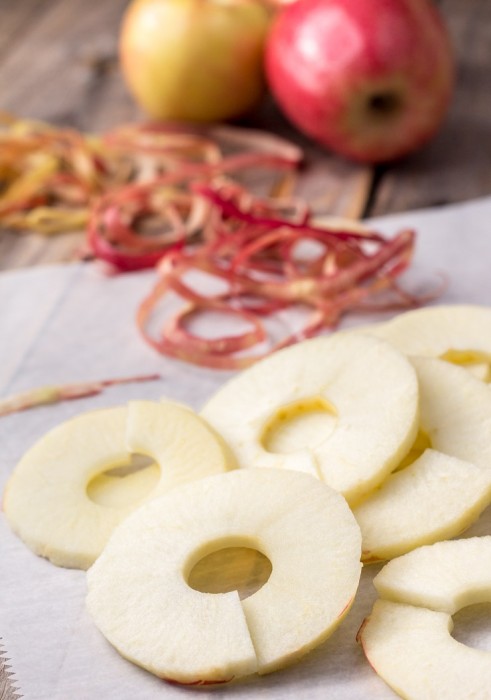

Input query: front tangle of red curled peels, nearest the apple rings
[137,183,426,370]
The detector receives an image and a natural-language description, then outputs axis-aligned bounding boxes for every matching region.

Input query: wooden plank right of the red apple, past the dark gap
[368,0,491,215]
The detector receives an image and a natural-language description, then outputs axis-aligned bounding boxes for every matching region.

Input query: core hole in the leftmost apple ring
[87,454,160,508]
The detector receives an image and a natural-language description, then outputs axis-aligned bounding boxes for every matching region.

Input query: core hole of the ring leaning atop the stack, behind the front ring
[261,397,337,454]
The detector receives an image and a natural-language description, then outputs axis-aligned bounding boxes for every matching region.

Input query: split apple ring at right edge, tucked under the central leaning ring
[353,357,491,563]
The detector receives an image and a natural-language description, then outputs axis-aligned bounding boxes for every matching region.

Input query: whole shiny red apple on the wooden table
[266,0,454,163]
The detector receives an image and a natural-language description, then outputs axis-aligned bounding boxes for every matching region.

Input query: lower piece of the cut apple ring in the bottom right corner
[358,600,491,700]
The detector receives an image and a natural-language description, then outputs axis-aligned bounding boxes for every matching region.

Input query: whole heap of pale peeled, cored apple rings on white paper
[4,305,491,700]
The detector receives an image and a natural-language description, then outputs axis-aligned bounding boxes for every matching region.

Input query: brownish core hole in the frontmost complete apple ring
[187,547,273,600]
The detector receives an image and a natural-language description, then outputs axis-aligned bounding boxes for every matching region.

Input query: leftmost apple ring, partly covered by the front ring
[3,401,235,569]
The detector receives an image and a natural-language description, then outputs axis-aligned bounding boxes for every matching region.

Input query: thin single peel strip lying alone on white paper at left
[0,374,161,417]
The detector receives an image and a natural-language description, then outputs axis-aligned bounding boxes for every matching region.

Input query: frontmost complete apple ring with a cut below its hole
[87,469,361,685]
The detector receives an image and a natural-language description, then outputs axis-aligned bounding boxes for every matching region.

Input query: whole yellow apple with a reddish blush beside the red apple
[120,0,270,121]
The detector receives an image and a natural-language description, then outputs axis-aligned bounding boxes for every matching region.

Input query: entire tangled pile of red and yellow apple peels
[0,115,435,369]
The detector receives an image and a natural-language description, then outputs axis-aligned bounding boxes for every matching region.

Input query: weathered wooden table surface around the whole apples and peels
[0,0,491,269]
